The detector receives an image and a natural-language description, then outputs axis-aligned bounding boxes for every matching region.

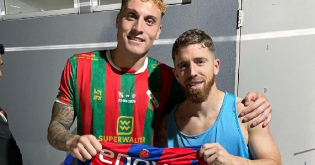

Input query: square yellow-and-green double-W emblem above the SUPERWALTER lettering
[117,116,134,135]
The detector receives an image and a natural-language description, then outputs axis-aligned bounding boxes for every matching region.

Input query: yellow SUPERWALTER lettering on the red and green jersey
[98,135,145,144]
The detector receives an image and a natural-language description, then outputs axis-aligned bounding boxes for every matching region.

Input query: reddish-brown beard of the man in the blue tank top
[180,75,215,104]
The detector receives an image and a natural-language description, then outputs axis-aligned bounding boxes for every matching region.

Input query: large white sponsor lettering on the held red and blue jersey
[99,149,168,165]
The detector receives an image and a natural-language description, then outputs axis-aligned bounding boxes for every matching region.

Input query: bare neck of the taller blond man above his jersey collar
[110,48,147,70]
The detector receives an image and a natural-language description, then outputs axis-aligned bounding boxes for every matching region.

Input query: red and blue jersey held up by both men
[64,142,207,165]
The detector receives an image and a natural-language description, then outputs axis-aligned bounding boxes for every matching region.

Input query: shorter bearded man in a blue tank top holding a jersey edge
[159,29,281,165]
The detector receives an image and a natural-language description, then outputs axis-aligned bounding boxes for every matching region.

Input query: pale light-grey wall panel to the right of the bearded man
[238,0,315,165]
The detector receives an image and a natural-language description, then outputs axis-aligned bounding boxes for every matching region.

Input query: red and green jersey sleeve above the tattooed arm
[57,60,74,106]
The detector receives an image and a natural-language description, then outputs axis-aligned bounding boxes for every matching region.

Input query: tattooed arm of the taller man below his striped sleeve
[47,102,75,151]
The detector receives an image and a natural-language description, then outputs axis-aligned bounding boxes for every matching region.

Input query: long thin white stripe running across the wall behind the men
[5,28,315,52]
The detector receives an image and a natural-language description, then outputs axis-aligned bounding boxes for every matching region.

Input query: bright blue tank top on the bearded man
[167,92,249,158]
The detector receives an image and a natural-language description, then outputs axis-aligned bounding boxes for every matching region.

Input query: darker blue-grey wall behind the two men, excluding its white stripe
[0,0,238,165]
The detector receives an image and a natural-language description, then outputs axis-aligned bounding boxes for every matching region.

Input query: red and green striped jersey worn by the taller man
[57,50,183,145]
